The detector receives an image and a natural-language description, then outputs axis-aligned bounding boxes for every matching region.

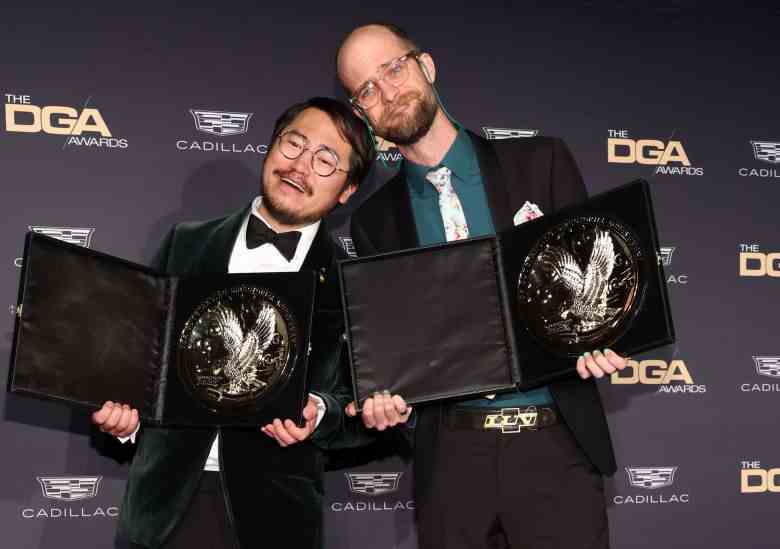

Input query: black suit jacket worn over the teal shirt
[352,133,615,475]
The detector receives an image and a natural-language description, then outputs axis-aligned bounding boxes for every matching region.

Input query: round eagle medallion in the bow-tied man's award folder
[178,286,297,414]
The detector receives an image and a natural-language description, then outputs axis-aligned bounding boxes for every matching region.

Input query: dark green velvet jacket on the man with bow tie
[118,203,369,548]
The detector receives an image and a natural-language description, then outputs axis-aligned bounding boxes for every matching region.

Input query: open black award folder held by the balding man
[340,180,674,403]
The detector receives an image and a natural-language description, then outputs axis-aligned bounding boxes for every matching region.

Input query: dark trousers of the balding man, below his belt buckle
[415,411,609,549]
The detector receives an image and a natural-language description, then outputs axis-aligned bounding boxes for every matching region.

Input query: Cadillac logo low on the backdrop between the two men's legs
[330,472,414,513]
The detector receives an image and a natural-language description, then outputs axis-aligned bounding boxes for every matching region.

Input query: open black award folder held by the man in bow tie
[8,233,316,426]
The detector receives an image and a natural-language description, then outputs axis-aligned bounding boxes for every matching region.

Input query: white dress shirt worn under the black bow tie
[119,196,325,471]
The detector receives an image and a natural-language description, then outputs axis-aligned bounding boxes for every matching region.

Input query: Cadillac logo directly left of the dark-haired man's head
[176,109,268,154]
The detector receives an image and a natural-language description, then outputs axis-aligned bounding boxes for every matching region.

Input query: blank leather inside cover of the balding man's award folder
[340,237,514,404]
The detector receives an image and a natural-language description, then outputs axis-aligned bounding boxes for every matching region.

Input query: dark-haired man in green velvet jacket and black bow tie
[93,97,374,549]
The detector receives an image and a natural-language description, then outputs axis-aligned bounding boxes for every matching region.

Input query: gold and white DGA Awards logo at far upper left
[5,93,127,149]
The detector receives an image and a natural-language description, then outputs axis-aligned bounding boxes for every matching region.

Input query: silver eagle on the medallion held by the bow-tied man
[210,305,276,395]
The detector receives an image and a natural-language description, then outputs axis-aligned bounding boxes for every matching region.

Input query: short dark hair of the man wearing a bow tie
[270,97,376,186]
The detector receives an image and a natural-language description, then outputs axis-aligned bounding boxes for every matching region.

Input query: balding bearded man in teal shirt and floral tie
[337,24,626,549]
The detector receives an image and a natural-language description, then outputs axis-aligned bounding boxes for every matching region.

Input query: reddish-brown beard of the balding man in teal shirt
[375,90,439,146]
